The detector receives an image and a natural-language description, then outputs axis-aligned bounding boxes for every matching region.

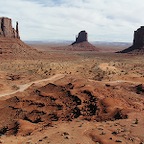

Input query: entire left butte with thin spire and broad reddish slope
[0,17,44,59]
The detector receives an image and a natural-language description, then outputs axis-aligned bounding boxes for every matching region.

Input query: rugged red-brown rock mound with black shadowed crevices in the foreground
[0,82,127,135]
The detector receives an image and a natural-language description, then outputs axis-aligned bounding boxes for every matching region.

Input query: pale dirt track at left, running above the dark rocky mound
[0,74,65,97]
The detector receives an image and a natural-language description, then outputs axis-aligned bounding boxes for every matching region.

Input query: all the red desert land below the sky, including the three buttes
[0,17,144,144]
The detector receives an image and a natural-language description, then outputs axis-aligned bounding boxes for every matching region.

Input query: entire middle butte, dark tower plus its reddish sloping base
[71,30,98,51]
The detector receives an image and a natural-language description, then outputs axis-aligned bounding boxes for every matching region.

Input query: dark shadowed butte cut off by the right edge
[120,26,144,54]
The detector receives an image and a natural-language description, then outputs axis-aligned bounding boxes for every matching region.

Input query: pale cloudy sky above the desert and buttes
[0,0,144,42]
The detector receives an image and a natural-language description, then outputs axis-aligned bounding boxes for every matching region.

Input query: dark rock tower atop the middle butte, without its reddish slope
[72,30,88,45]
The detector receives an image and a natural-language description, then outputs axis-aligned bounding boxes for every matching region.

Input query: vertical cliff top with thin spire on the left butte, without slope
[0,17,20,39]
